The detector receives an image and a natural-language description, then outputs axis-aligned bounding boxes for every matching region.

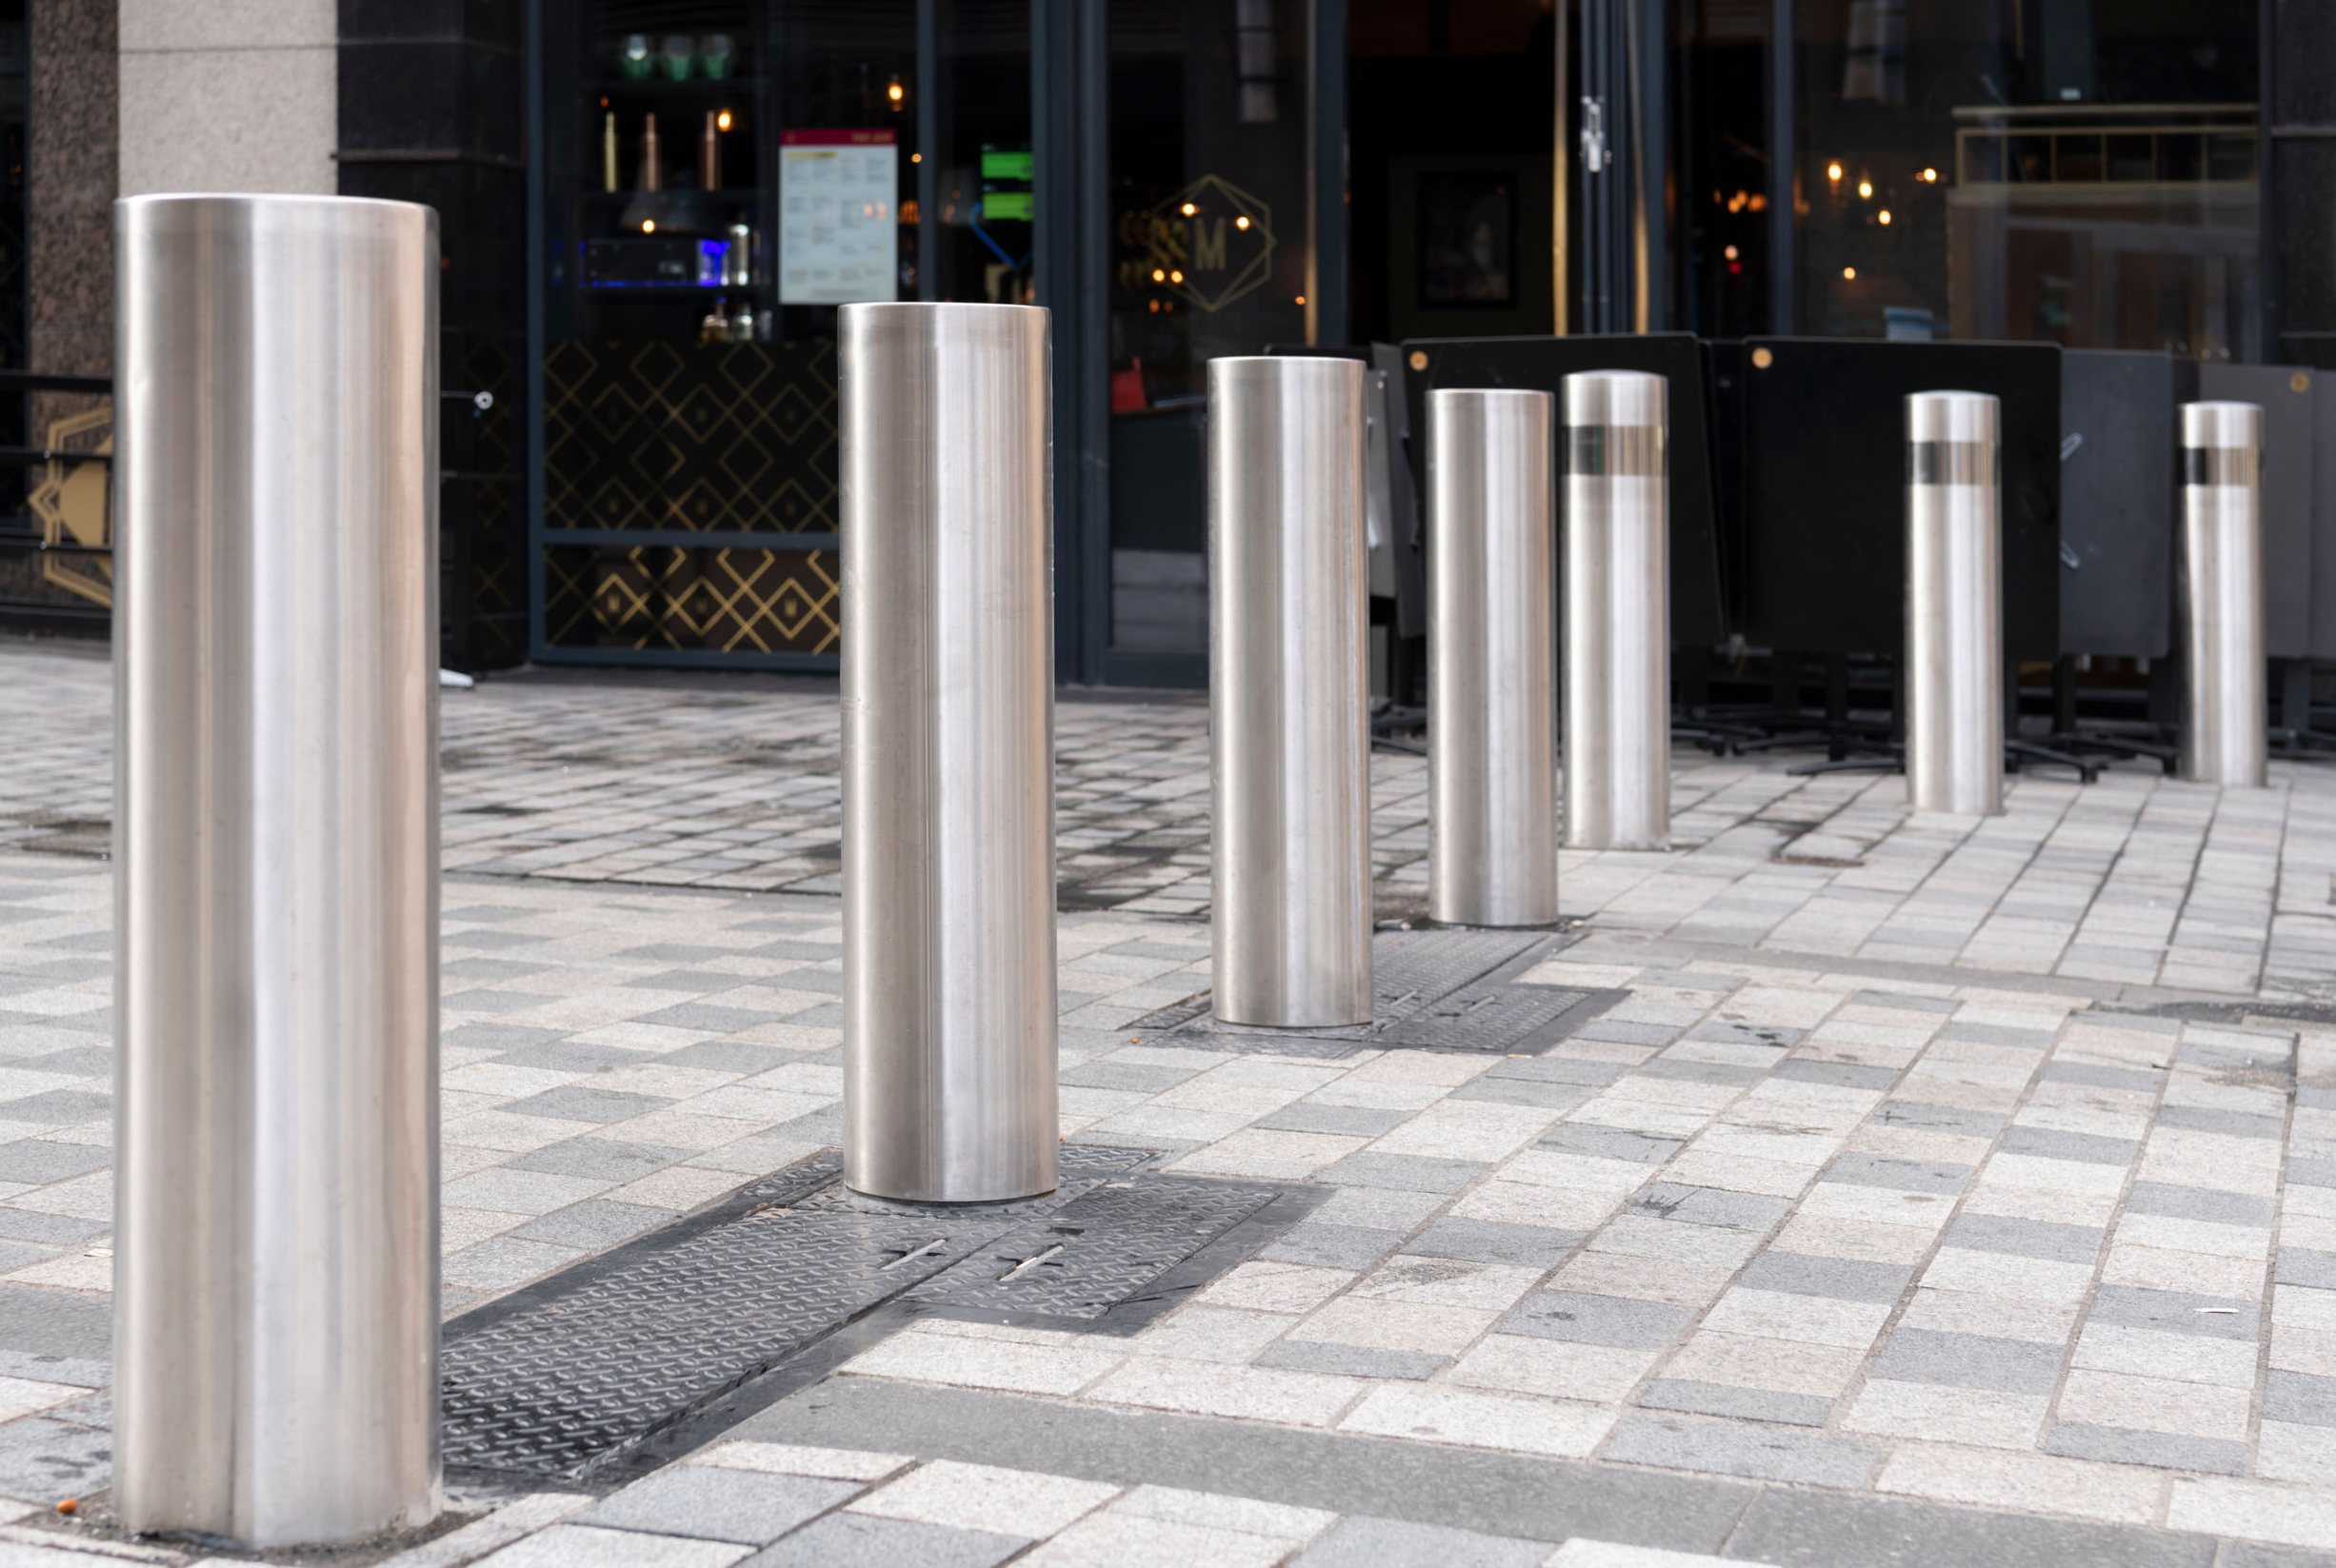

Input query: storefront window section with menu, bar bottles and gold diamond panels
[537,0,1035,668]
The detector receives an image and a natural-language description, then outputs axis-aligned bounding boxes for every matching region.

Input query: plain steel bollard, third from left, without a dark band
[1208,355,1371,1028]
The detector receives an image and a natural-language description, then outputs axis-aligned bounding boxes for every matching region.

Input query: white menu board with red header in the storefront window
[778,130,899,304]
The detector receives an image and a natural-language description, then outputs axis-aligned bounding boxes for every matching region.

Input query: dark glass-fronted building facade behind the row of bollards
[0,0,2336,685]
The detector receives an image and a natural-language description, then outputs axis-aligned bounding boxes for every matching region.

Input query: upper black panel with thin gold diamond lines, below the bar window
[545,341,836,533]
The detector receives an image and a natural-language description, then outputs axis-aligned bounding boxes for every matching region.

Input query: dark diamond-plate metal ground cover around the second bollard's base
[442,1145,1283,1479]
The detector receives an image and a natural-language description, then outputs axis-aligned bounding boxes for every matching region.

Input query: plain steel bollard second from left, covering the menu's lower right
[836,304,1061,1203]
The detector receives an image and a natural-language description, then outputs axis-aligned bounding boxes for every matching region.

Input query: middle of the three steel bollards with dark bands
[1902,392,2005,816]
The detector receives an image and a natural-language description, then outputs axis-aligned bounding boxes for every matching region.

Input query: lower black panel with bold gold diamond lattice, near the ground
[545,545,841,654]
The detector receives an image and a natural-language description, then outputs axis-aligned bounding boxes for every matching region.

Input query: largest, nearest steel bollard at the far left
[114,196,439,1547]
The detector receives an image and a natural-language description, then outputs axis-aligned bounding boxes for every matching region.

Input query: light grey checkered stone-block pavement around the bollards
[0,649,2336,1568]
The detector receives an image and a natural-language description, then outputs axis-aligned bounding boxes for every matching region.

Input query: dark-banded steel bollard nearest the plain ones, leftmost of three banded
[1566,369,1670,848]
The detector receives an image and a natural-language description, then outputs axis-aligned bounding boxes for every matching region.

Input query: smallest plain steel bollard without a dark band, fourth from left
[1428,390,1558,925]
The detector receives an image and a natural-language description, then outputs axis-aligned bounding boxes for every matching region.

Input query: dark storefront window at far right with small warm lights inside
[1794,0,2262,360]
